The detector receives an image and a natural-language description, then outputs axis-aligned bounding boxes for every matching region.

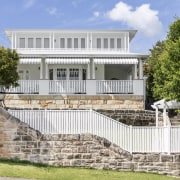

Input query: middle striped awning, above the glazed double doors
[45,58,90,64]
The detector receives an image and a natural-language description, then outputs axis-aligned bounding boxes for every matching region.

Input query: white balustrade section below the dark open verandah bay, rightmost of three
[96,80,133,94]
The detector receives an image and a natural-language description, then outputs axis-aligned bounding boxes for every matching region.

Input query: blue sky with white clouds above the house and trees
[0,0,180,53]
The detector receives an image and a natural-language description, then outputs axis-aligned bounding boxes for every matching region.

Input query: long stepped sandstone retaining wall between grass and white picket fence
[0,108,180,177]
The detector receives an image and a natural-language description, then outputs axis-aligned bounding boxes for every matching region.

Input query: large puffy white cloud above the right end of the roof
[106,1,162,37]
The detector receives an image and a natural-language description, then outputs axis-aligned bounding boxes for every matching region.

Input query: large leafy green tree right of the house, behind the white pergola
[147,18,180,101]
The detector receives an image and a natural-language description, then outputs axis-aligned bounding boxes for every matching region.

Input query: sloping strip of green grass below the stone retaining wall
[0,160,177,180]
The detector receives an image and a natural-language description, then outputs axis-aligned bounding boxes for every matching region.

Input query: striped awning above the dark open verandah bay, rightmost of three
[94,58,138,64]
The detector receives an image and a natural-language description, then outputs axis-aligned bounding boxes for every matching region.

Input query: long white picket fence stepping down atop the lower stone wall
[9,110,180,153]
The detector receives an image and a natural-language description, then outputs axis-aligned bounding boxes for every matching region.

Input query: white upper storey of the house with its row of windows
[9,30,136,52]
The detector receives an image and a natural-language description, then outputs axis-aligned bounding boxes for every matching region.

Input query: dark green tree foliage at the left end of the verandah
[0,47,19,88]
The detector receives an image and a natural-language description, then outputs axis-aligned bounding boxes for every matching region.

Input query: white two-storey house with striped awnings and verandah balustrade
[5,29,147,96]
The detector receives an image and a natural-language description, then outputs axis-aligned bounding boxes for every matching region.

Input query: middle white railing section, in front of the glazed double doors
[49,80,86,94]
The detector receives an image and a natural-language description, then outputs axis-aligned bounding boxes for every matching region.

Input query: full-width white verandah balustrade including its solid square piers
[0,80,144,95]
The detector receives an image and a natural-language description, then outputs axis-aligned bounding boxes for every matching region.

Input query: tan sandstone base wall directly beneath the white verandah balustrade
[4,94,144,110]
